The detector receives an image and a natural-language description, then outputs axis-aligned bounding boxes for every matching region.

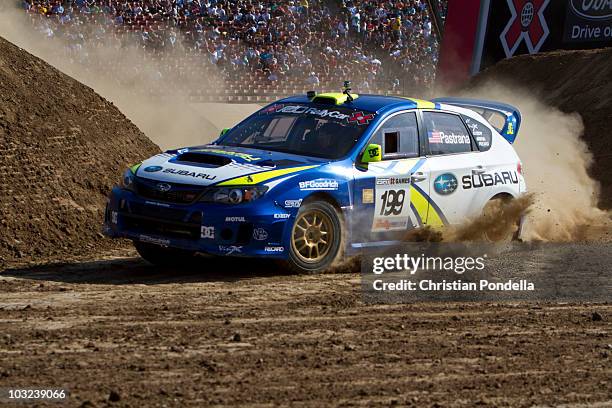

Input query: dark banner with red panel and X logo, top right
[438,0,612,83]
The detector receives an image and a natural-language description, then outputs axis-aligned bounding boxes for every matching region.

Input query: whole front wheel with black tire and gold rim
[288,201,343,273]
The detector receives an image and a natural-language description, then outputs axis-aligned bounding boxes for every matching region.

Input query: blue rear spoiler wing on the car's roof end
[432,98,521,143]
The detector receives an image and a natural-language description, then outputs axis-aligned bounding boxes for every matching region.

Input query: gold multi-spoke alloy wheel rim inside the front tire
[291,210,335,263]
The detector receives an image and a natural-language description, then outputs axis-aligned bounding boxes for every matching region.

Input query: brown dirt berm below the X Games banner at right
[467,48,612,209]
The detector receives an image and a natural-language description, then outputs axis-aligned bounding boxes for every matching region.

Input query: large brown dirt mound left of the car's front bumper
[0,38,159,269]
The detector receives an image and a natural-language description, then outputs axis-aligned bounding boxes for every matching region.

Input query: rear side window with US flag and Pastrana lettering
[423,112,472,155]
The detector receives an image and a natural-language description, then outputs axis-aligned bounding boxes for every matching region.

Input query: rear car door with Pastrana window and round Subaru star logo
[412,111,486,226]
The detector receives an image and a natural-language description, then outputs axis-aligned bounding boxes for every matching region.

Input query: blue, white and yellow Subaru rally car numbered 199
[104,89,525,271]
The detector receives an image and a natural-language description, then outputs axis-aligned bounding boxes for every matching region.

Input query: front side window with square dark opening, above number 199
[370,112,419,160]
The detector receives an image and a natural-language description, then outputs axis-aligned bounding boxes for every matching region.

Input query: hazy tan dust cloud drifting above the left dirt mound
[0,2,234,149]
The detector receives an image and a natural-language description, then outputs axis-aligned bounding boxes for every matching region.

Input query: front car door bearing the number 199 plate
[353,110,421,242]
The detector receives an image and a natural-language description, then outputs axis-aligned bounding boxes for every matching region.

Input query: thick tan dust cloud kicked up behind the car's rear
[453,82,609,242]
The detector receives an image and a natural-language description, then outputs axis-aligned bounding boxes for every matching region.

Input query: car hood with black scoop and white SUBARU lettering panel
[136,145,326,186]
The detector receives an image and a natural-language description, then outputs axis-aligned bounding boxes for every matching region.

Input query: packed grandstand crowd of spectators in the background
[20,0,446,100]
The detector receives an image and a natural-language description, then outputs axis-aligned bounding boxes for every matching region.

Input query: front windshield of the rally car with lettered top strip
[217,104,374,159]
